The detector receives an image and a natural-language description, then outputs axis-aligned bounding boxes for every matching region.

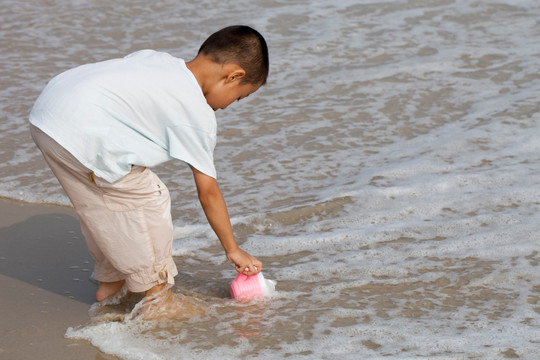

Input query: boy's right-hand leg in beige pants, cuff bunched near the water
[86,166,178,292]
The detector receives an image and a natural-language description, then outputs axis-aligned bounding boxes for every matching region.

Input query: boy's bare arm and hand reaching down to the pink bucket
[191,167,262,275]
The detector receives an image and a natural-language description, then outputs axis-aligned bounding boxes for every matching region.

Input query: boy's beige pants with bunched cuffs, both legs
[31,125,178,292]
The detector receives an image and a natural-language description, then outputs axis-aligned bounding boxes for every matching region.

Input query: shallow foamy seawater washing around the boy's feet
[0,0,540,360]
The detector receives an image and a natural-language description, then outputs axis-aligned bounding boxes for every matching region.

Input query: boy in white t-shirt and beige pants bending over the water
[30,26,269,301]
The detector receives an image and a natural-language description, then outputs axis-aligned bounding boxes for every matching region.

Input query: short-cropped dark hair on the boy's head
[199,25,269,85]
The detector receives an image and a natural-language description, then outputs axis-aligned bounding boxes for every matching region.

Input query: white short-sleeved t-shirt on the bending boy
[30,50,217,182]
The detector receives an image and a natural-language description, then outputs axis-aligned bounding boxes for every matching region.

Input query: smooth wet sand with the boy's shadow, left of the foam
[0,199,116,360]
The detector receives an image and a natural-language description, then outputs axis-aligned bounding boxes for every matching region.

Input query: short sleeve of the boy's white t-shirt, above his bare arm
[167,125,217,179]
